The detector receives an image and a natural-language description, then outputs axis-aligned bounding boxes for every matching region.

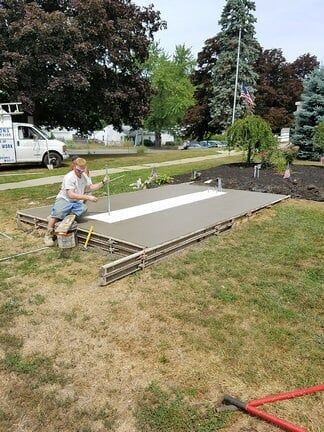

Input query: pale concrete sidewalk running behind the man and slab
[0,151,235,191]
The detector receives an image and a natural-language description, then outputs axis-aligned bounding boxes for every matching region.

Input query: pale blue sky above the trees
[132,0,324,64]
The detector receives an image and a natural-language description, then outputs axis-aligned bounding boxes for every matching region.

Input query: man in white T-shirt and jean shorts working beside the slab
[44,158,109,246]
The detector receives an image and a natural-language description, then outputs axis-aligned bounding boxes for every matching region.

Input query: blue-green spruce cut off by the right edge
[292,67,324,151]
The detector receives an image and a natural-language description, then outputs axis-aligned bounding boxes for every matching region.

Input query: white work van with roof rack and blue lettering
[0,102,69,168]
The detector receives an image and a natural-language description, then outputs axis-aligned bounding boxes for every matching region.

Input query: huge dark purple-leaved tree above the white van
[0,0,164,131]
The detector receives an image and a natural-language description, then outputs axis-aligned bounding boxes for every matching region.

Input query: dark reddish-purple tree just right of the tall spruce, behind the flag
[255,49,318,132]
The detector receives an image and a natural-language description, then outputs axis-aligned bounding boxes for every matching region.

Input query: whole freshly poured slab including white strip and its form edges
[17,183,289,283]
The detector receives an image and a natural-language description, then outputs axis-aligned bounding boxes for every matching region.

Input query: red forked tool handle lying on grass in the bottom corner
[223,384,324,432]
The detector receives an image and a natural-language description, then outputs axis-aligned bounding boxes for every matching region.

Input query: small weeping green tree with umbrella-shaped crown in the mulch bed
[227,115,278,163]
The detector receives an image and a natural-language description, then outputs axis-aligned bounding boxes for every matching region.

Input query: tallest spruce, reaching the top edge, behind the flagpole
[210,0,260,132]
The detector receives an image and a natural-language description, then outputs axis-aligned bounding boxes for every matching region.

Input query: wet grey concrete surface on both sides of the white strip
[18,184,287,248]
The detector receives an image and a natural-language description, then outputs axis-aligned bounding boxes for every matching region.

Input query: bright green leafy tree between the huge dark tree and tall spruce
[144,45,194,147]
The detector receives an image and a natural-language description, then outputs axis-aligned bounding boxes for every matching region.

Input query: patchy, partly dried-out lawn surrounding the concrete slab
[0,159,324,432]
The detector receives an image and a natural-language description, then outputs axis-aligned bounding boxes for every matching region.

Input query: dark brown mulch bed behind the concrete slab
[175,163,324,201]
